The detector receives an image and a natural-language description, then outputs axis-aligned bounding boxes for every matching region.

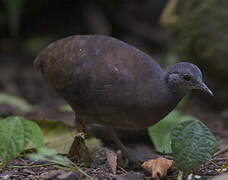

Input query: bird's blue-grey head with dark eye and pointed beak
[166,62,213,96]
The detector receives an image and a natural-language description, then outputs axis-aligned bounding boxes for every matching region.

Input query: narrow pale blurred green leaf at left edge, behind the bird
[0,92,32,113]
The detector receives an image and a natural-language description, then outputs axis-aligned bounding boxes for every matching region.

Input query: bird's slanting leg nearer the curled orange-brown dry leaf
[108,127,141,167]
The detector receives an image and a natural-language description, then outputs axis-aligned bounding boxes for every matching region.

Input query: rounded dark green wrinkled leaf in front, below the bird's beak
[171,120,218,172]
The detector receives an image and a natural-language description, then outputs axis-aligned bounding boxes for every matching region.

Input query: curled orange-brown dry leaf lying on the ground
[142,157,174,179]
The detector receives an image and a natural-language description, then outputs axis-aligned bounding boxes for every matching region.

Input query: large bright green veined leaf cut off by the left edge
[0,116,44,166]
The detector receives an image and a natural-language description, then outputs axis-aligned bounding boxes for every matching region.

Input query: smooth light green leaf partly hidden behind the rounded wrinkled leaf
[148,110,195,153]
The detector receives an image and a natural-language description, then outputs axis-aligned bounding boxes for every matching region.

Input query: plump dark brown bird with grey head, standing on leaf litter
[34,35,213,163]
